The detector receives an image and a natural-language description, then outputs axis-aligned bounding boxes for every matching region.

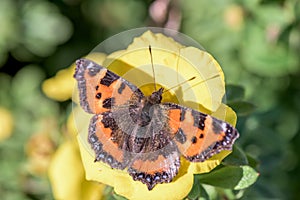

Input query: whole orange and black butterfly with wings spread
[74,59,239,190]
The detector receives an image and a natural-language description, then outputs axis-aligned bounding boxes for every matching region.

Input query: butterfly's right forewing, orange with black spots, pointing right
[163,103,239,162]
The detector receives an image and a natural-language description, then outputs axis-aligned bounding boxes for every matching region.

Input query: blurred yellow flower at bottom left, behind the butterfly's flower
[49,111,105,200]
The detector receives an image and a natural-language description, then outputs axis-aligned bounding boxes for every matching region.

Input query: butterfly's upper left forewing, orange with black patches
[74,59,144,114]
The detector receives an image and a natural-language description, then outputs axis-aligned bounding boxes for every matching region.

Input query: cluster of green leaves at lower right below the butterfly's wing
[188,145,259,199]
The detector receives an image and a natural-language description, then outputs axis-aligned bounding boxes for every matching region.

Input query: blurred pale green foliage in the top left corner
[0,0,72,63]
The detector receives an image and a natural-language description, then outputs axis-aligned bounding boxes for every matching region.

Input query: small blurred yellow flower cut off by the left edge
[0,107,13,141]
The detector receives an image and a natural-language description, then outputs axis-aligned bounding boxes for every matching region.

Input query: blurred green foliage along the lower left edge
[0,66,58,199]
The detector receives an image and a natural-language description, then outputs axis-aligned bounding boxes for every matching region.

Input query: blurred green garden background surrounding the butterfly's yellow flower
[0,0,300,199]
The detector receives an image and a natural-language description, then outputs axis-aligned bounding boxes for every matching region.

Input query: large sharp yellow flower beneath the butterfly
[73,31,236,199]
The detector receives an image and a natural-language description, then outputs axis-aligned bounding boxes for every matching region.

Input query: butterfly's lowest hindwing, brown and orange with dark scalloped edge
[128,130,180,190]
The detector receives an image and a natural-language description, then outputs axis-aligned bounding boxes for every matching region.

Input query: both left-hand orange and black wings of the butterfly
[74,59,144,169]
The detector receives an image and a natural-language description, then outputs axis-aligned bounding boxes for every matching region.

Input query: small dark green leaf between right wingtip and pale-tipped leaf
[222,145,249,166]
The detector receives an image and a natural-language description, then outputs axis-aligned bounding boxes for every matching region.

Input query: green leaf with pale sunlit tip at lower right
[197,165,259,190]
